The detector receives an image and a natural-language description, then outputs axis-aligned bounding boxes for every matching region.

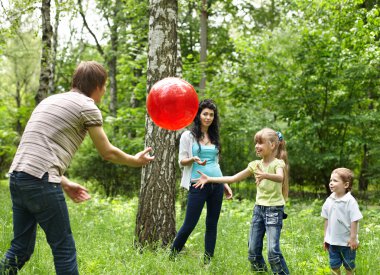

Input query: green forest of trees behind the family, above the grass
[0,0,380,196]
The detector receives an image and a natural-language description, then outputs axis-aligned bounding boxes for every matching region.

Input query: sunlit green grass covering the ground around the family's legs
[0,181,380,275]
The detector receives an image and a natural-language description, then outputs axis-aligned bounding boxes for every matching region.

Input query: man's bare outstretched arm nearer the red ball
[88,126,154,167]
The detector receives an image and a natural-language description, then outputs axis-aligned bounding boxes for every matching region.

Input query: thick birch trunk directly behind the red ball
[136,0,178,248]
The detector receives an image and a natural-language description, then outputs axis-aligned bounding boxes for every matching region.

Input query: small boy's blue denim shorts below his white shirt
[329,245,356,270]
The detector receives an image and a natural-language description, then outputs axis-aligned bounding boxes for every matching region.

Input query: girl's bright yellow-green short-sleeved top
[248,159,285,206]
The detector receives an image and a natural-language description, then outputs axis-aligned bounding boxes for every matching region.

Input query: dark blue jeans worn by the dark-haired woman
[171,184,224,257]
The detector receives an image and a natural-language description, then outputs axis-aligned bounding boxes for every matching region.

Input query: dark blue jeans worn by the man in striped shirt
[0,172,78,274]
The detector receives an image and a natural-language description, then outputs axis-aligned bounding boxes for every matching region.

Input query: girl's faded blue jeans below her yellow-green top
[248,205,289,274]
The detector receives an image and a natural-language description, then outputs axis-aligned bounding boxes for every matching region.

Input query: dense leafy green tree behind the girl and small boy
[231,1,379,191]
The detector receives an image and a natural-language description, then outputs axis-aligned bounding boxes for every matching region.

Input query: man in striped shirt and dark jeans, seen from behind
[0,61,154,274]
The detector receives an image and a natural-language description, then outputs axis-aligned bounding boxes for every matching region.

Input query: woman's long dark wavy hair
[191,99,221,155]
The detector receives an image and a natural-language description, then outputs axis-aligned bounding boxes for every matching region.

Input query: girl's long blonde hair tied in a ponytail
[254,128,289,200]
